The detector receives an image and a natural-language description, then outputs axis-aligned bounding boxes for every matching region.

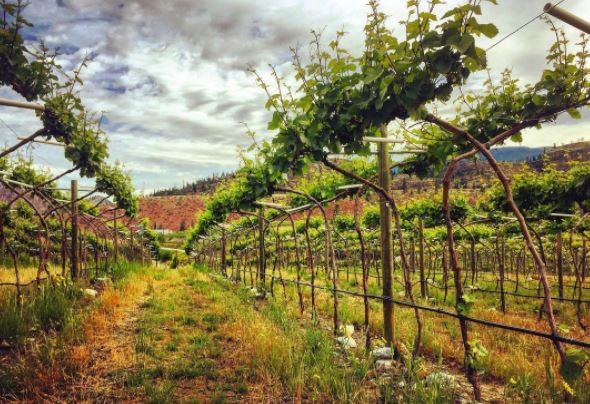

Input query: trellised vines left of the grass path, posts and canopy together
[0,1,159,316]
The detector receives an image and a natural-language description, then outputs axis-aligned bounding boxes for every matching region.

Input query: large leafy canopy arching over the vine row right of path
[186,1,495,248]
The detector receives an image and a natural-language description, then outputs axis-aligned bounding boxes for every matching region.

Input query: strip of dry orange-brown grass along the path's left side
[0,266,153,402]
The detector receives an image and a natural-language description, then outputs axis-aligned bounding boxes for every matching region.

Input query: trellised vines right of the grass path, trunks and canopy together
[186,0,590,401]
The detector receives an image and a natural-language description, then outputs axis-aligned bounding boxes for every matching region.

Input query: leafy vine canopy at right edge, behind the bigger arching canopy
[402,21,590,176]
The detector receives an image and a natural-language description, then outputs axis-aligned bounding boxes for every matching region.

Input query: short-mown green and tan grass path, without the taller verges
[81,270,280,403]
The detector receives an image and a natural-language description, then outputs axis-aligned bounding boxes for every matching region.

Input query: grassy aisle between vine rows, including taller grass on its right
[77,269,508,403]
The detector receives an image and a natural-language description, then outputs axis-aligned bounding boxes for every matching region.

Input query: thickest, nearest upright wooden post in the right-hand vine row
[377,127,395,347]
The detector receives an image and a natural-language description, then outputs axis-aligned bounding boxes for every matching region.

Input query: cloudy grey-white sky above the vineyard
[0,0,590,193]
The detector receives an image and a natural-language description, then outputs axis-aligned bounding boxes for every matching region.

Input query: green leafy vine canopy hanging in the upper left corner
[0,0,121,197]
